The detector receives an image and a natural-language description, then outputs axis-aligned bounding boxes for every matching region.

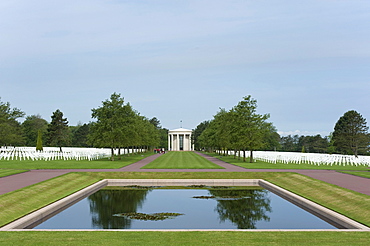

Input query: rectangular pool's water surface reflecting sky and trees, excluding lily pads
[35,189,336,229]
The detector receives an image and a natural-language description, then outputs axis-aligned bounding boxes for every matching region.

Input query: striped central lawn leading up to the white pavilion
[142,151,223,169]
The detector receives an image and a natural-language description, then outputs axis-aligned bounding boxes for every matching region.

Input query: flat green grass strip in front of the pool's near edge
[0,231,370,246]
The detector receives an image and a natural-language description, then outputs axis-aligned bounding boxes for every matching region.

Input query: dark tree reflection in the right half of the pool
[209,190,271,229]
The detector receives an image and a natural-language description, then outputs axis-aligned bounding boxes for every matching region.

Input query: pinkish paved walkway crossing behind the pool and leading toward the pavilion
[0,153,370,195]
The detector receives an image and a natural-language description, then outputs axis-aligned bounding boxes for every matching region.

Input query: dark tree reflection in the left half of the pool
[88,190,149,229]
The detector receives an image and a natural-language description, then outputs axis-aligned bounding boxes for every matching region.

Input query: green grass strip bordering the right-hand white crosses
[205,153,369,171]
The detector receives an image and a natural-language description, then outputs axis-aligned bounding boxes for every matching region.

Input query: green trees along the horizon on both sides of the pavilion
[0,93,370,161]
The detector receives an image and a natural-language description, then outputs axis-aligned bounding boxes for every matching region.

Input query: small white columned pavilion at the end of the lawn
[168,128,193,151]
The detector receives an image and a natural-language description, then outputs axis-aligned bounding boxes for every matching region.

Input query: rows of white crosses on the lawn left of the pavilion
[0,147,142,161]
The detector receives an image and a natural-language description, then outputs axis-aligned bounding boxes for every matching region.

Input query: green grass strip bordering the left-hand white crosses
[0,152,154,169]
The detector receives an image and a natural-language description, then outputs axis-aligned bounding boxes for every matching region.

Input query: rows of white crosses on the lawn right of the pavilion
[218,151,370,167]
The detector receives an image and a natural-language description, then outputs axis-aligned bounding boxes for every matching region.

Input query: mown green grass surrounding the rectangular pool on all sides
[0,172,370,245]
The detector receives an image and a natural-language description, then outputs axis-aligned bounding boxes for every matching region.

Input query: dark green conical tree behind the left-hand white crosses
[47,109,70,152]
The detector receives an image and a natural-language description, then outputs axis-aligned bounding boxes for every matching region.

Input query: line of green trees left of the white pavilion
[0,93,168,159]
